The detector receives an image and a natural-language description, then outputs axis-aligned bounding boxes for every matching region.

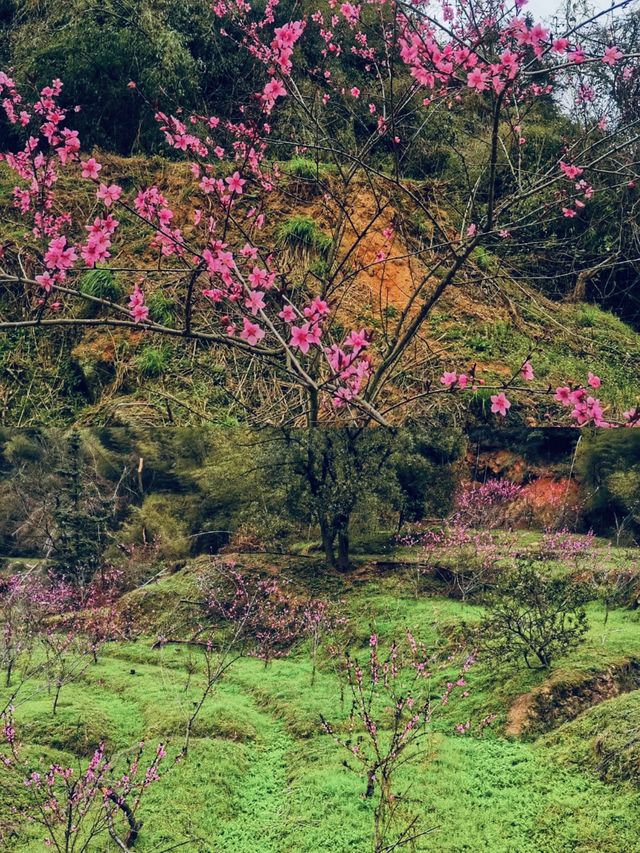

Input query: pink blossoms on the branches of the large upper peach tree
[0,0,640,426]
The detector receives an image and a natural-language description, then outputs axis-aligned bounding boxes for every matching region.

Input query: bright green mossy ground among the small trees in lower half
[0,536,640,853]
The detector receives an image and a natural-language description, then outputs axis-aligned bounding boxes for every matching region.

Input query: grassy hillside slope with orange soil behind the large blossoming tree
[0,152,640,426]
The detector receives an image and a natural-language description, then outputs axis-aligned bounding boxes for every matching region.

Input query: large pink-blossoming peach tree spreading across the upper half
[0,0,639,426]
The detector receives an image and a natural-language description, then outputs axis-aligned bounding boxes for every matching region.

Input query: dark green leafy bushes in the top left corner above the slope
[5,0,258,155]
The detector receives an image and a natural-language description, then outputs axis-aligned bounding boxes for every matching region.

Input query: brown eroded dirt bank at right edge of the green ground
[505,659,640,736]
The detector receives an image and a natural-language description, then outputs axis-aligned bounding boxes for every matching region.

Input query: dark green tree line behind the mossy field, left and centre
[0,428,466,580]
